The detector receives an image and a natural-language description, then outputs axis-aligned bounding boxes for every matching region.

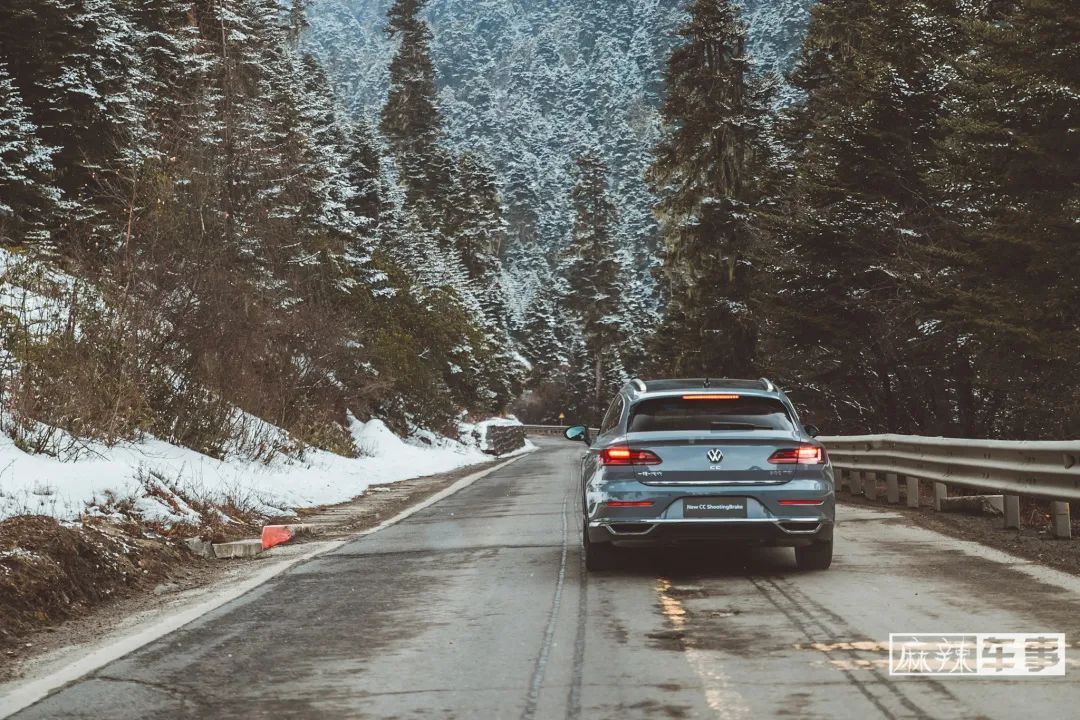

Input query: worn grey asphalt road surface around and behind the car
[15,440,1080,720]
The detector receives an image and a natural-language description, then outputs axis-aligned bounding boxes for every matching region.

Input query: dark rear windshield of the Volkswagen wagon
[629,396,794,433]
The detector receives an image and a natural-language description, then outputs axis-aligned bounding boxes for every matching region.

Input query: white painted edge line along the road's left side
[0,450,531,720]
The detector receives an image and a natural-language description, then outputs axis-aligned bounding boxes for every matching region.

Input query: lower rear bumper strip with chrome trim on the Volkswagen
[588,517,834,547]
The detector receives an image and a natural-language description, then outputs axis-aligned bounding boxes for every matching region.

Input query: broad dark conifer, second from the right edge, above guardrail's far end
[769,0,962,433]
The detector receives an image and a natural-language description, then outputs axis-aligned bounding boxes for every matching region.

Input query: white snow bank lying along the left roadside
[0,418,527,522]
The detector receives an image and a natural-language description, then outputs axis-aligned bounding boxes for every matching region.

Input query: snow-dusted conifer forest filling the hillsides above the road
[0,0,1080,456]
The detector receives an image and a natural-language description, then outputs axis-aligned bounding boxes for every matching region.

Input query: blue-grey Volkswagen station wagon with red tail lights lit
[565,378,836,570]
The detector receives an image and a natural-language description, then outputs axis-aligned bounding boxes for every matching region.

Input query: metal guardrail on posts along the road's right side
[820,435,1080,538]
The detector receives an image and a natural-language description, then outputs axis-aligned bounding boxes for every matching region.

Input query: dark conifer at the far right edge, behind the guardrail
[926,0,1080,438]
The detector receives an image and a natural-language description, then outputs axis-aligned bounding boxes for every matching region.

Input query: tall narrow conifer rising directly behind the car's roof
[649,0,771,377]
